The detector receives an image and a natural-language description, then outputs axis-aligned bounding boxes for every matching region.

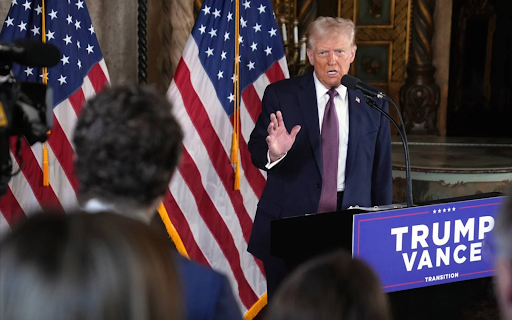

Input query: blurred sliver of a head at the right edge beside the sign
[495,195,512,320]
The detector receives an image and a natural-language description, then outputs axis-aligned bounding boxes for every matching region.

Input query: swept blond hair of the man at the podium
[307,17,357,49]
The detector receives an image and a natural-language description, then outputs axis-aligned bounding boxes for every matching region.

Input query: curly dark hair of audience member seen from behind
[73,86,183,206]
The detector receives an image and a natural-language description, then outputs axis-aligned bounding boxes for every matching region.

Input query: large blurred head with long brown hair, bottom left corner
[0,213,182,320]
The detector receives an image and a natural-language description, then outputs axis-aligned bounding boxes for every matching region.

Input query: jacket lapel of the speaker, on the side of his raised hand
[298,73,322,174]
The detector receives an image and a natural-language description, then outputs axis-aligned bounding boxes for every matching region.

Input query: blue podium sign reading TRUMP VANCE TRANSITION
[352,197,505,292]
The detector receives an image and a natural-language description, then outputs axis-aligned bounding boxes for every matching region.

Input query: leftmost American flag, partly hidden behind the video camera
[0,0,109,232]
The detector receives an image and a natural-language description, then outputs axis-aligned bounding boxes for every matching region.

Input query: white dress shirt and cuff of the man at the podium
[265,72,349,191]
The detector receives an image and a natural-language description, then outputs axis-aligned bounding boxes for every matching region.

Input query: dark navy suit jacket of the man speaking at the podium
[248,73,392,261]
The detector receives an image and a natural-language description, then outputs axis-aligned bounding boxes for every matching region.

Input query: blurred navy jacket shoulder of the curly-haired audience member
[175,253,242,320]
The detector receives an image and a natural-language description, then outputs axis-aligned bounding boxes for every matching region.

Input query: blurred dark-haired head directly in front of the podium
[267,251,390,320]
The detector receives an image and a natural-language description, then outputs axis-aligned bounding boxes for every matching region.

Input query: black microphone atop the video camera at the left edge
[0,38,61,68]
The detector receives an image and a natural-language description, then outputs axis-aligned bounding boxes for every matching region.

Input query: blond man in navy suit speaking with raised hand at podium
[248,17,392,299]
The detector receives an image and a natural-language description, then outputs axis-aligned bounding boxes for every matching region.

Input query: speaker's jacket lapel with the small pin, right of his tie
[345,90,369,176]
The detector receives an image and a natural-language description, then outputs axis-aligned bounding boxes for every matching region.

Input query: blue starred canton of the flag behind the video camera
[0,0,102,107]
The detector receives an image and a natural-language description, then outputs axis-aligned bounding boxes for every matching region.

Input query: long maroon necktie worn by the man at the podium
[318,88,339,213]
